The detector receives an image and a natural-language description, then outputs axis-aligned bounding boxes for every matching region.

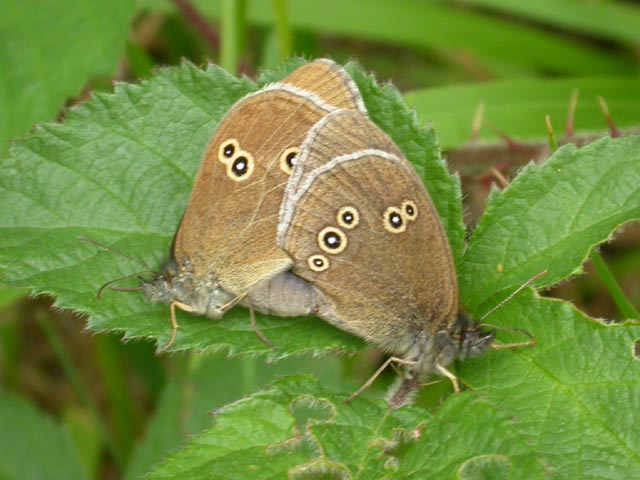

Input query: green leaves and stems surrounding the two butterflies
[0,0,640,479]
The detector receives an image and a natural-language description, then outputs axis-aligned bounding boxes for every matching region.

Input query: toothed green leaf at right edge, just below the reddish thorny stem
[458,135,640,313]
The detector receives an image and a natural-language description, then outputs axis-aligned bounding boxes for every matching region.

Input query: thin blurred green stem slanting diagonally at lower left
[36,313,124,468]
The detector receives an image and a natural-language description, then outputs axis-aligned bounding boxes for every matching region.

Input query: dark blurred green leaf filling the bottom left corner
[0,393,87,480]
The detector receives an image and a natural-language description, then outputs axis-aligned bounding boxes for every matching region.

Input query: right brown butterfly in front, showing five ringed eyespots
[278,110,494,407]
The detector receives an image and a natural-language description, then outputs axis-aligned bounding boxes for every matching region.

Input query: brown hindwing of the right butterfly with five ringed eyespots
[280,113,458,354]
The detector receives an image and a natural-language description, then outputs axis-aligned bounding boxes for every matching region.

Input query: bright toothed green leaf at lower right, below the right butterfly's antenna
[456,293,640,479]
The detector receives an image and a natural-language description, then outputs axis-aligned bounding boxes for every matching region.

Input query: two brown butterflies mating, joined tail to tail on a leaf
[144,60,493,406]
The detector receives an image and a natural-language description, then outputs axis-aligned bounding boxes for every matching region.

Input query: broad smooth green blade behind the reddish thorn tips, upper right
[404,77,640,150]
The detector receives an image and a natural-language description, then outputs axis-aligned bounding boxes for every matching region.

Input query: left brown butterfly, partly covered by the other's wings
[143,59,366,350]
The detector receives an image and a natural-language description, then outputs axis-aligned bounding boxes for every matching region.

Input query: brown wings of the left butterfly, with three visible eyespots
[174,61,364,295]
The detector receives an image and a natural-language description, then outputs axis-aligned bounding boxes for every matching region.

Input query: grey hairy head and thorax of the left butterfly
[142,260,234,318]
